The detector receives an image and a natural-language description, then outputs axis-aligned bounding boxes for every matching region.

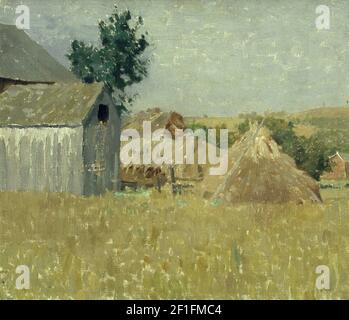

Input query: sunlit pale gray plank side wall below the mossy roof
[0,126,83,194]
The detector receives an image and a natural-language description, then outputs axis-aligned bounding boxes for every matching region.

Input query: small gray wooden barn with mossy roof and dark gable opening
[0,83,120,195]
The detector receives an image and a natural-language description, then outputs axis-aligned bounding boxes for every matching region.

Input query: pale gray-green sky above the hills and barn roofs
[0,0,349,115]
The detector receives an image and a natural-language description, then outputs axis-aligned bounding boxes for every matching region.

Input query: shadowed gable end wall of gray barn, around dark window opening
[83,93,121,195]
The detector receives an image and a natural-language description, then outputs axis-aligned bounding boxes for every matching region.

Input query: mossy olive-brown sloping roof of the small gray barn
[0,83,103,126]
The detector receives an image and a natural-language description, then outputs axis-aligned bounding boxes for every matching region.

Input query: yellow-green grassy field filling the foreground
[0,189,349,299]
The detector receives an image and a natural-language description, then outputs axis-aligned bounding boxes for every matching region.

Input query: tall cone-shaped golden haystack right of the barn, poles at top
[209,127,322,204]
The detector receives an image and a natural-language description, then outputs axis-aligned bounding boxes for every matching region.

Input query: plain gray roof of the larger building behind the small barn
[0,23,76,82]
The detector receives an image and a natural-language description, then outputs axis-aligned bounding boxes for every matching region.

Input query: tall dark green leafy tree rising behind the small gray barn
[67,6,150,113]
